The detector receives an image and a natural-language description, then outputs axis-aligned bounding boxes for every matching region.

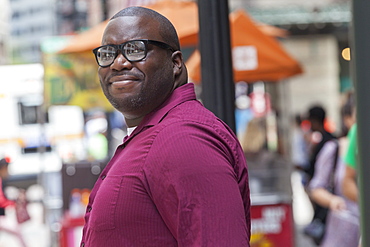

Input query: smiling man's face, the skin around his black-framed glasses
[98,16,174,120]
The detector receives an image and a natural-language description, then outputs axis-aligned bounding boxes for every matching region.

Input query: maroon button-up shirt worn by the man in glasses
[81,83,250,247]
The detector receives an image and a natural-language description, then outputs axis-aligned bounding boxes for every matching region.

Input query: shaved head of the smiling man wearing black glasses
[95,7,187,126]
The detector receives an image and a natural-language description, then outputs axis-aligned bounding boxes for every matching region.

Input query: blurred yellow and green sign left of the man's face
[44,51,113,111]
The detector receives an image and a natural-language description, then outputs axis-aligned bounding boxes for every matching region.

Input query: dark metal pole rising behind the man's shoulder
[198,0,235,132]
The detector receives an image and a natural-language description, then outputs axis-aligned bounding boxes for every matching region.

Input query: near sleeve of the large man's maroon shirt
[145,123,250,247]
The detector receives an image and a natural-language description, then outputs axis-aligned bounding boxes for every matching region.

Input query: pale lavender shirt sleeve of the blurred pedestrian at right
[308,141,337,190]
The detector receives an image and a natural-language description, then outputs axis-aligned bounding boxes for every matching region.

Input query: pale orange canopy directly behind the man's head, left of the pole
[59,0,199,53]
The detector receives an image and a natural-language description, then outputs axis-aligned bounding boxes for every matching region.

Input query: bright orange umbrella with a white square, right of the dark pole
[186,10,302,82]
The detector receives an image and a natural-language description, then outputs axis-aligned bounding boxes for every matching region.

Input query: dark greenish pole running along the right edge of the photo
[350,0,370,247]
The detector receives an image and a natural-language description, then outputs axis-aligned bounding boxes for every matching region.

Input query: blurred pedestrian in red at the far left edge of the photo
[0,157,26,247]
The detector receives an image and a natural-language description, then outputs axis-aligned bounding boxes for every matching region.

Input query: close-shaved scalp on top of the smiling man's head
[110,6,180,50]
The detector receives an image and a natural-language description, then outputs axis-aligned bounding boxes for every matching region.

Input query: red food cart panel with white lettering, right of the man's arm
[250,204,294,247]
